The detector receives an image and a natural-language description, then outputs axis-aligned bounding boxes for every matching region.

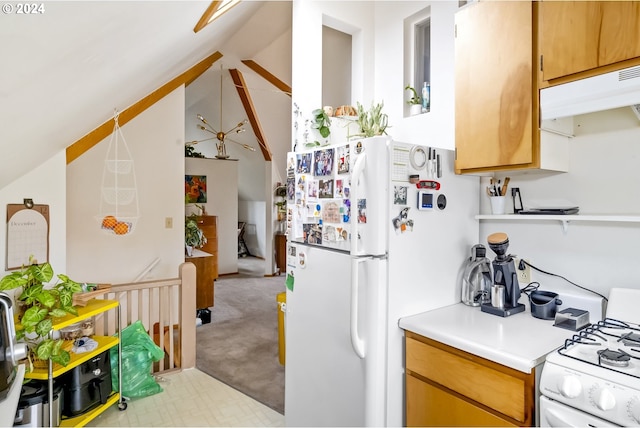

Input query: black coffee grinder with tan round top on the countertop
[480,232,525,317]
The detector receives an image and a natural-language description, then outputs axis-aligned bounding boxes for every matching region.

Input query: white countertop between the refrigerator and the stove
[399,299,574,373]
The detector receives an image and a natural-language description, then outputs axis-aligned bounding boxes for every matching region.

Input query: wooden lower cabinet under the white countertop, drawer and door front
[406,332,535,426]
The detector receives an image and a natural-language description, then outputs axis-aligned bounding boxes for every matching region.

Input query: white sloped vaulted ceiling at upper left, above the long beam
[0,0,291,188]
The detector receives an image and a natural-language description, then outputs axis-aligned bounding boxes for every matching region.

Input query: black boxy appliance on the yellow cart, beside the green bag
[62,351,112,417]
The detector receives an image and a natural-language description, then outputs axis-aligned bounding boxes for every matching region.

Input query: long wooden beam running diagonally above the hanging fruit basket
[66,51,222,165]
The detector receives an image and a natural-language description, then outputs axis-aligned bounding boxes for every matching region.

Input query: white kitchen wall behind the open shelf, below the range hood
[480,107,640,296]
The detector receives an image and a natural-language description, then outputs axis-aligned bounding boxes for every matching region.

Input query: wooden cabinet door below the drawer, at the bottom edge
[406,375,518,427]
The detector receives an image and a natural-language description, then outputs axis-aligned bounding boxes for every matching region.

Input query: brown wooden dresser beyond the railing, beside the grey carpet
[185,215,218,309]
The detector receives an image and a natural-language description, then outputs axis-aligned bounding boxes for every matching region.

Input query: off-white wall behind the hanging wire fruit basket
[61,87,184,283]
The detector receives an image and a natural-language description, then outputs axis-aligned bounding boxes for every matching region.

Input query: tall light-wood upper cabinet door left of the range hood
[455,1,537,172]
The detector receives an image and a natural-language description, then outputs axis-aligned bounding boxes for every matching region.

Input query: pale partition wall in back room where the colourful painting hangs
[182,158,239,274]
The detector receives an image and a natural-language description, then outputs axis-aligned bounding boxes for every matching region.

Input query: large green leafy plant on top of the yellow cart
[0,263,82,366]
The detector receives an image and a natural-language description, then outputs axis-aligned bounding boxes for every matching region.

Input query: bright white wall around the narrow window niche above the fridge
[375,1,458,150]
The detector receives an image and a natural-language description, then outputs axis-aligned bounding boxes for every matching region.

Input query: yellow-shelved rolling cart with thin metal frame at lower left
[24,299,127,427]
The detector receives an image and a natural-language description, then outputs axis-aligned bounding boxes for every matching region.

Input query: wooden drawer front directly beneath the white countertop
[406,333,534,422]
